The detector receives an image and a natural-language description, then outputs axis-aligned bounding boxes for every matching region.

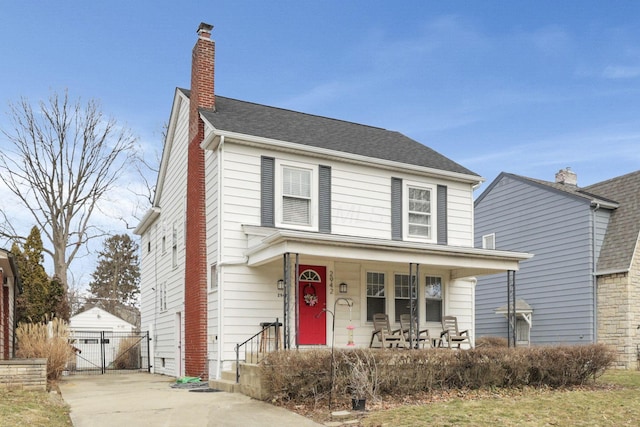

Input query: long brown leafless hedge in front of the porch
[261,344,615,405]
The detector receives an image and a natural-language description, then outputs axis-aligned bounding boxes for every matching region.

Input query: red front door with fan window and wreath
[298,265,327,345]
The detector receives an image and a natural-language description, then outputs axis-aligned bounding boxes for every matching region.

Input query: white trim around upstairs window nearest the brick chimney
[274,159,320,231]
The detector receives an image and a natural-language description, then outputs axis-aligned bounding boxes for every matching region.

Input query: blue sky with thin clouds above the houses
[0,0,640,286]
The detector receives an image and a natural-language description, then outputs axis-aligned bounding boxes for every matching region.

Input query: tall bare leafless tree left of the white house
[0,91,135,293]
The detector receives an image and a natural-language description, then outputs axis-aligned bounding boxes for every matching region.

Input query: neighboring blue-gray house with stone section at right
[475,168,640,368]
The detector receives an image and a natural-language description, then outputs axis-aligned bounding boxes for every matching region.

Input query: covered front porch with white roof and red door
[244,226,532,348]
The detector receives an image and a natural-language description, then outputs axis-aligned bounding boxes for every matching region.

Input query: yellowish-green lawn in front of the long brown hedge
[362,371,640,427]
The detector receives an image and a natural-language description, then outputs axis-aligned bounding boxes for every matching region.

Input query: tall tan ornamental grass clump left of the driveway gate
[16,318,74,381]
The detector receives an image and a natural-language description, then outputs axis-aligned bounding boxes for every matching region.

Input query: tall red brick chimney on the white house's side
[183,23,215,379]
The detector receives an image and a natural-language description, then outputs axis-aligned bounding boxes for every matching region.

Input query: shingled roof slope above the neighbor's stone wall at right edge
[584,171,640,271]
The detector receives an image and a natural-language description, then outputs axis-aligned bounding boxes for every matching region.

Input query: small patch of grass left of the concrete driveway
[0,389,71,427]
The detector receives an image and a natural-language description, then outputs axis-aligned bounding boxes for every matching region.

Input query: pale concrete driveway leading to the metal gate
[59,373,321,427]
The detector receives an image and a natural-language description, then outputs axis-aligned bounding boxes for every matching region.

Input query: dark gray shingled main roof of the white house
[180,89,479,177]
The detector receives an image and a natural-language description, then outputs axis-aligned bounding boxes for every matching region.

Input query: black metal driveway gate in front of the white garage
[67,331,151,375]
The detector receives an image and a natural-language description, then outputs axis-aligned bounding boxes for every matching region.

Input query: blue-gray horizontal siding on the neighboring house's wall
[475,176,594,345]
